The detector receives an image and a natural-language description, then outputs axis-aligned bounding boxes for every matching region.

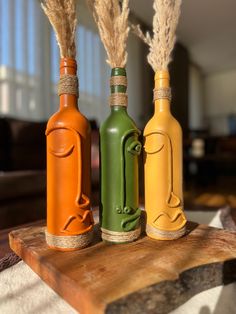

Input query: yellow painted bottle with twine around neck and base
[144,71,186,240]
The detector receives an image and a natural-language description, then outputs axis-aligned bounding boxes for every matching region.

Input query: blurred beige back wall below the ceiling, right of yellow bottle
[189,64,236,135]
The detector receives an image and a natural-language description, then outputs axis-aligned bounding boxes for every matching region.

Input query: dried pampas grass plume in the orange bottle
[41,0,77,58]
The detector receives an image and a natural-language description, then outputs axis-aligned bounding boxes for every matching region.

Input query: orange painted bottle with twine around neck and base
[46,58,93,251]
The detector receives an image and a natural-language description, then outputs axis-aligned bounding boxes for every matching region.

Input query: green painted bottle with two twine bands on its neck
[100,68,141,243]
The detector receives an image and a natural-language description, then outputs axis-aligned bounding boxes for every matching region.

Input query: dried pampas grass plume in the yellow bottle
[132,0,182,72]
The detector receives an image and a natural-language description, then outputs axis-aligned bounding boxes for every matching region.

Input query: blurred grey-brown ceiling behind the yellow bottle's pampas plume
[130,0,236,74]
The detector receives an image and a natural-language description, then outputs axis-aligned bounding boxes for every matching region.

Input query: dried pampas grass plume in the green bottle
[87,0,129,68]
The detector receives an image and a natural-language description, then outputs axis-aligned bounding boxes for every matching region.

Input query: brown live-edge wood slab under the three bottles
[9,216,236,314]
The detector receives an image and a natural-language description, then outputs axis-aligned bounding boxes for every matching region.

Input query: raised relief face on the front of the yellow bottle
[144,131,184,228]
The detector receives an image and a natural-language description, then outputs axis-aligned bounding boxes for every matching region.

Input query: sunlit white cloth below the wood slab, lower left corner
[0,262,77,314]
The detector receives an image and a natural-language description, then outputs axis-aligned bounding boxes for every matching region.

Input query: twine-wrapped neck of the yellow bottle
[154,71,170,113]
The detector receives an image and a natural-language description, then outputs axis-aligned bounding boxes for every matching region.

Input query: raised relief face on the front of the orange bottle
[47,128,91,235]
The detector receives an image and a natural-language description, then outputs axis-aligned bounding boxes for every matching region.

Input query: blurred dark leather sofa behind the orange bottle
[0,118,99,229]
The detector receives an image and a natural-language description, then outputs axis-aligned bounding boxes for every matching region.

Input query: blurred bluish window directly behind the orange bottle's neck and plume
[51,25,110,123]
